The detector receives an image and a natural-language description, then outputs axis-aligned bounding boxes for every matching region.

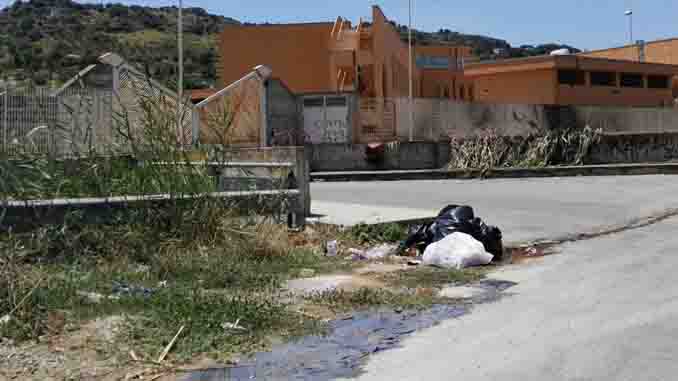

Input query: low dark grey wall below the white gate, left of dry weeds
[308,141,450,172]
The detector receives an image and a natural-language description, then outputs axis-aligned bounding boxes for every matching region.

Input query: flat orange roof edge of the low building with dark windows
[464,54,678,76]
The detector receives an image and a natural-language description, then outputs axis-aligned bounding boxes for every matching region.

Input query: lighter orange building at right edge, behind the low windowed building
[580,38,678,98]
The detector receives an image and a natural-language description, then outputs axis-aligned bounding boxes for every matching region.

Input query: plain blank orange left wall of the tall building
[219,23,332,93]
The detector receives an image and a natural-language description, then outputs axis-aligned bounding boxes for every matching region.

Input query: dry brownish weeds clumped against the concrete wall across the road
[449,127,602,170]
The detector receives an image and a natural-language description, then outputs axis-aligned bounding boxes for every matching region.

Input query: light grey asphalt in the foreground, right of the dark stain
[346,214,678,381]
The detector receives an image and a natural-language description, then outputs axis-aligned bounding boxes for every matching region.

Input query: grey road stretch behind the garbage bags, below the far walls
[311,175,678,242]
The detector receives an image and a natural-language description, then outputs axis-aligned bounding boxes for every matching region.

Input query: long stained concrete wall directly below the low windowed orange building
[393,98,678,141]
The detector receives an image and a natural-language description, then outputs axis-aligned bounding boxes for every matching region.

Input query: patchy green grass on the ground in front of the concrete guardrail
[0,218,339,360]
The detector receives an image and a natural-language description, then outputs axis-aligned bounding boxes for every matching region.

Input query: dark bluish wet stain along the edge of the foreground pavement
[184,279,516,381]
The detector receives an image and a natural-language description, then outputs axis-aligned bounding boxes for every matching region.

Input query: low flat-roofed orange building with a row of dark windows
[464,55,678,107]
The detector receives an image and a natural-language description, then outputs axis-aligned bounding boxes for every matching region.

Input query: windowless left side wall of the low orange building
[473,70,556,104]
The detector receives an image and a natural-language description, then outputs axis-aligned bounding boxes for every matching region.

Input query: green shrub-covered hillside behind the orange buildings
[0,0,577,88]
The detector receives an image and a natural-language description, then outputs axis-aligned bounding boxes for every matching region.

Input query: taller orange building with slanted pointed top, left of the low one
[219,6,471,98]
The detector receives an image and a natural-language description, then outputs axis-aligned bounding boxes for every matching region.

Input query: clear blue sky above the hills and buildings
[65,0,678,49]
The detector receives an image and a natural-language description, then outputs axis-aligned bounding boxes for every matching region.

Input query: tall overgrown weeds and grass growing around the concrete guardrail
[0,70,308,357]
